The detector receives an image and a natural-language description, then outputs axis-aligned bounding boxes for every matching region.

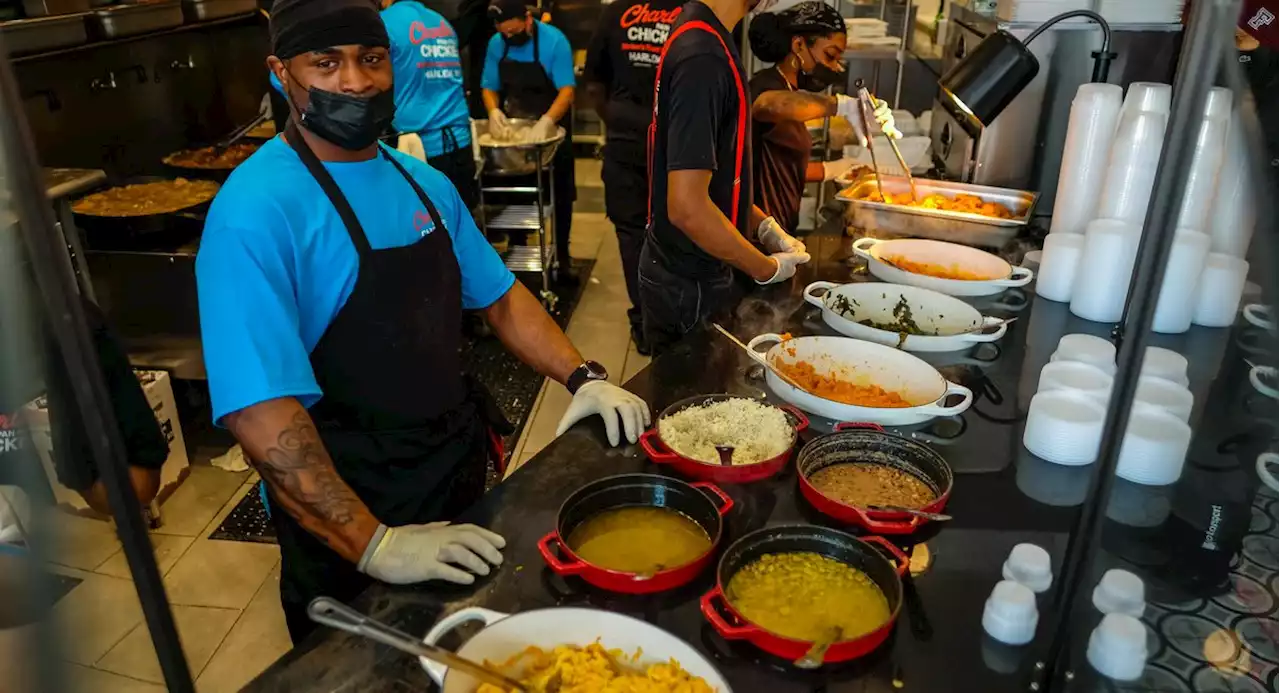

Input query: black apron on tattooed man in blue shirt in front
[270,122,486,643]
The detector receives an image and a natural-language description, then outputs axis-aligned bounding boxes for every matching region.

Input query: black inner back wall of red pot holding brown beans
[796,429,952,500]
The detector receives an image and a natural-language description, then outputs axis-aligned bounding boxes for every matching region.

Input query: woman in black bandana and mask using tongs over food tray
[748,1,902,233]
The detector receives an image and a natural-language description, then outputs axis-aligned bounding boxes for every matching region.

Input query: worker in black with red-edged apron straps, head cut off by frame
[639,0,809,354]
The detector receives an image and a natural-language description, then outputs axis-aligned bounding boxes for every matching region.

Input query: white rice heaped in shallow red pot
[658,398,795,465]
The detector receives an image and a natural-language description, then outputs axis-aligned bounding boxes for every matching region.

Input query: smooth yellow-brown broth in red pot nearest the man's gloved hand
[568,506,712,573]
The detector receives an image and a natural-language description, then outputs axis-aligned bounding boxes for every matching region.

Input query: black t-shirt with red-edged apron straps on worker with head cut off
[649,0,751,278]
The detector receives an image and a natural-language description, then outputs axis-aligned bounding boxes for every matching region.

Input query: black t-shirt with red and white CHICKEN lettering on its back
[584,0,682,164]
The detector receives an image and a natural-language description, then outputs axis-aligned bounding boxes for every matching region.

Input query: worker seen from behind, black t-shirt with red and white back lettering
[582,0,682,354]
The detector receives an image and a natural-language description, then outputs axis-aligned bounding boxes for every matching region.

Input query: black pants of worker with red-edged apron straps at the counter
[637,241,740,356]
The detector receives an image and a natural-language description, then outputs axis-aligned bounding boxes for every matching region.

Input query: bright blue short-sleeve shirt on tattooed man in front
[196,137,515,421]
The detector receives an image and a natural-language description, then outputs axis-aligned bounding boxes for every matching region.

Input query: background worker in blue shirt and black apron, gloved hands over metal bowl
[480,0,577,283]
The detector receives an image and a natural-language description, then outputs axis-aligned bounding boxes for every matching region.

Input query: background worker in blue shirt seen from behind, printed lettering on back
[383,0,480,208]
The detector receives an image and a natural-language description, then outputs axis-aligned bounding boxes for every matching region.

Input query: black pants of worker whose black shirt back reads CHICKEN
[600,153,649,334]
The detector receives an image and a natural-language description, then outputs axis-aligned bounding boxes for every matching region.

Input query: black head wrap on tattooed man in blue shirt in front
[271,0,390,60]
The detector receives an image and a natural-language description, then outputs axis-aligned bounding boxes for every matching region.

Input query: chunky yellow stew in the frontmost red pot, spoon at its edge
[724,552,890,642]
